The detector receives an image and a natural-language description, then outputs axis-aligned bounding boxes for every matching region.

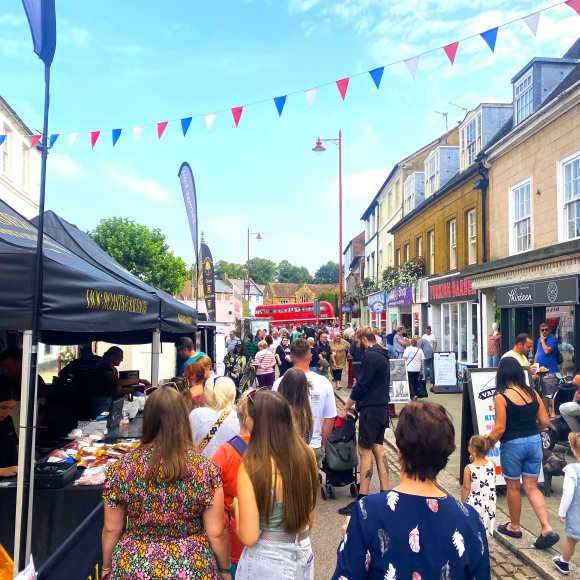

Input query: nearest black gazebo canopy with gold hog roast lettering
[0,201,159,344]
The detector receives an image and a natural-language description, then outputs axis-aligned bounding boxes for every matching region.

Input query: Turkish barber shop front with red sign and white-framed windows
[428,276,481,366]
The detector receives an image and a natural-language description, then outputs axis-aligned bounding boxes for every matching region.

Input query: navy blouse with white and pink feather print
[332,491,491,580]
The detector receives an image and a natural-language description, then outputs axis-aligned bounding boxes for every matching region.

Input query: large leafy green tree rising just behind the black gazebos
[89,217,189,294]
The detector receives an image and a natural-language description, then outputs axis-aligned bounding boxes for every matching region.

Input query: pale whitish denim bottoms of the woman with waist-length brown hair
[236,538,314,580]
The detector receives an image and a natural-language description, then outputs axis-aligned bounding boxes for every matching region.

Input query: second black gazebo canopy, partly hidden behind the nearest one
[32,211,197,340]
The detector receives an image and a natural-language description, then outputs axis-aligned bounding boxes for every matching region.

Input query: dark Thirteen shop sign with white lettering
[495,276,578,308]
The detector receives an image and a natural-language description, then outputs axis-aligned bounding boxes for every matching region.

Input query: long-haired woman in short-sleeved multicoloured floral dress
[102,387,230,580]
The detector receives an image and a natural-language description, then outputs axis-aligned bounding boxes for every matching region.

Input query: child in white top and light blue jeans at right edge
[552,433,580,575]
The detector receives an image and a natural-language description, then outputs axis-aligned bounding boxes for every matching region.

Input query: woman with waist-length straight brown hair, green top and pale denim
[232,390,318,580]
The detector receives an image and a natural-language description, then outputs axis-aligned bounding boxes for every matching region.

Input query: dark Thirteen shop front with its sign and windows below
[495,276,580,375]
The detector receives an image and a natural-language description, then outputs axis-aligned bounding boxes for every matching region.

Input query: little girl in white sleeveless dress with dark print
[461,435,496,536]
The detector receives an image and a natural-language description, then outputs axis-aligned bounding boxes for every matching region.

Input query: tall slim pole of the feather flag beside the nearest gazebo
[14,65,50,570]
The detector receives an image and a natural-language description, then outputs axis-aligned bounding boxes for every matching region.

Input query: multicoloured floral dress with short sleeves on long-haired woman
[103,448,222,580]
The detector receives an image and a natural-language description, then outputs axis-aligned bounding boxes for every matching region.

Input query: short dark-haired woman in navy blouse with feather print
[332,402,490,580]
